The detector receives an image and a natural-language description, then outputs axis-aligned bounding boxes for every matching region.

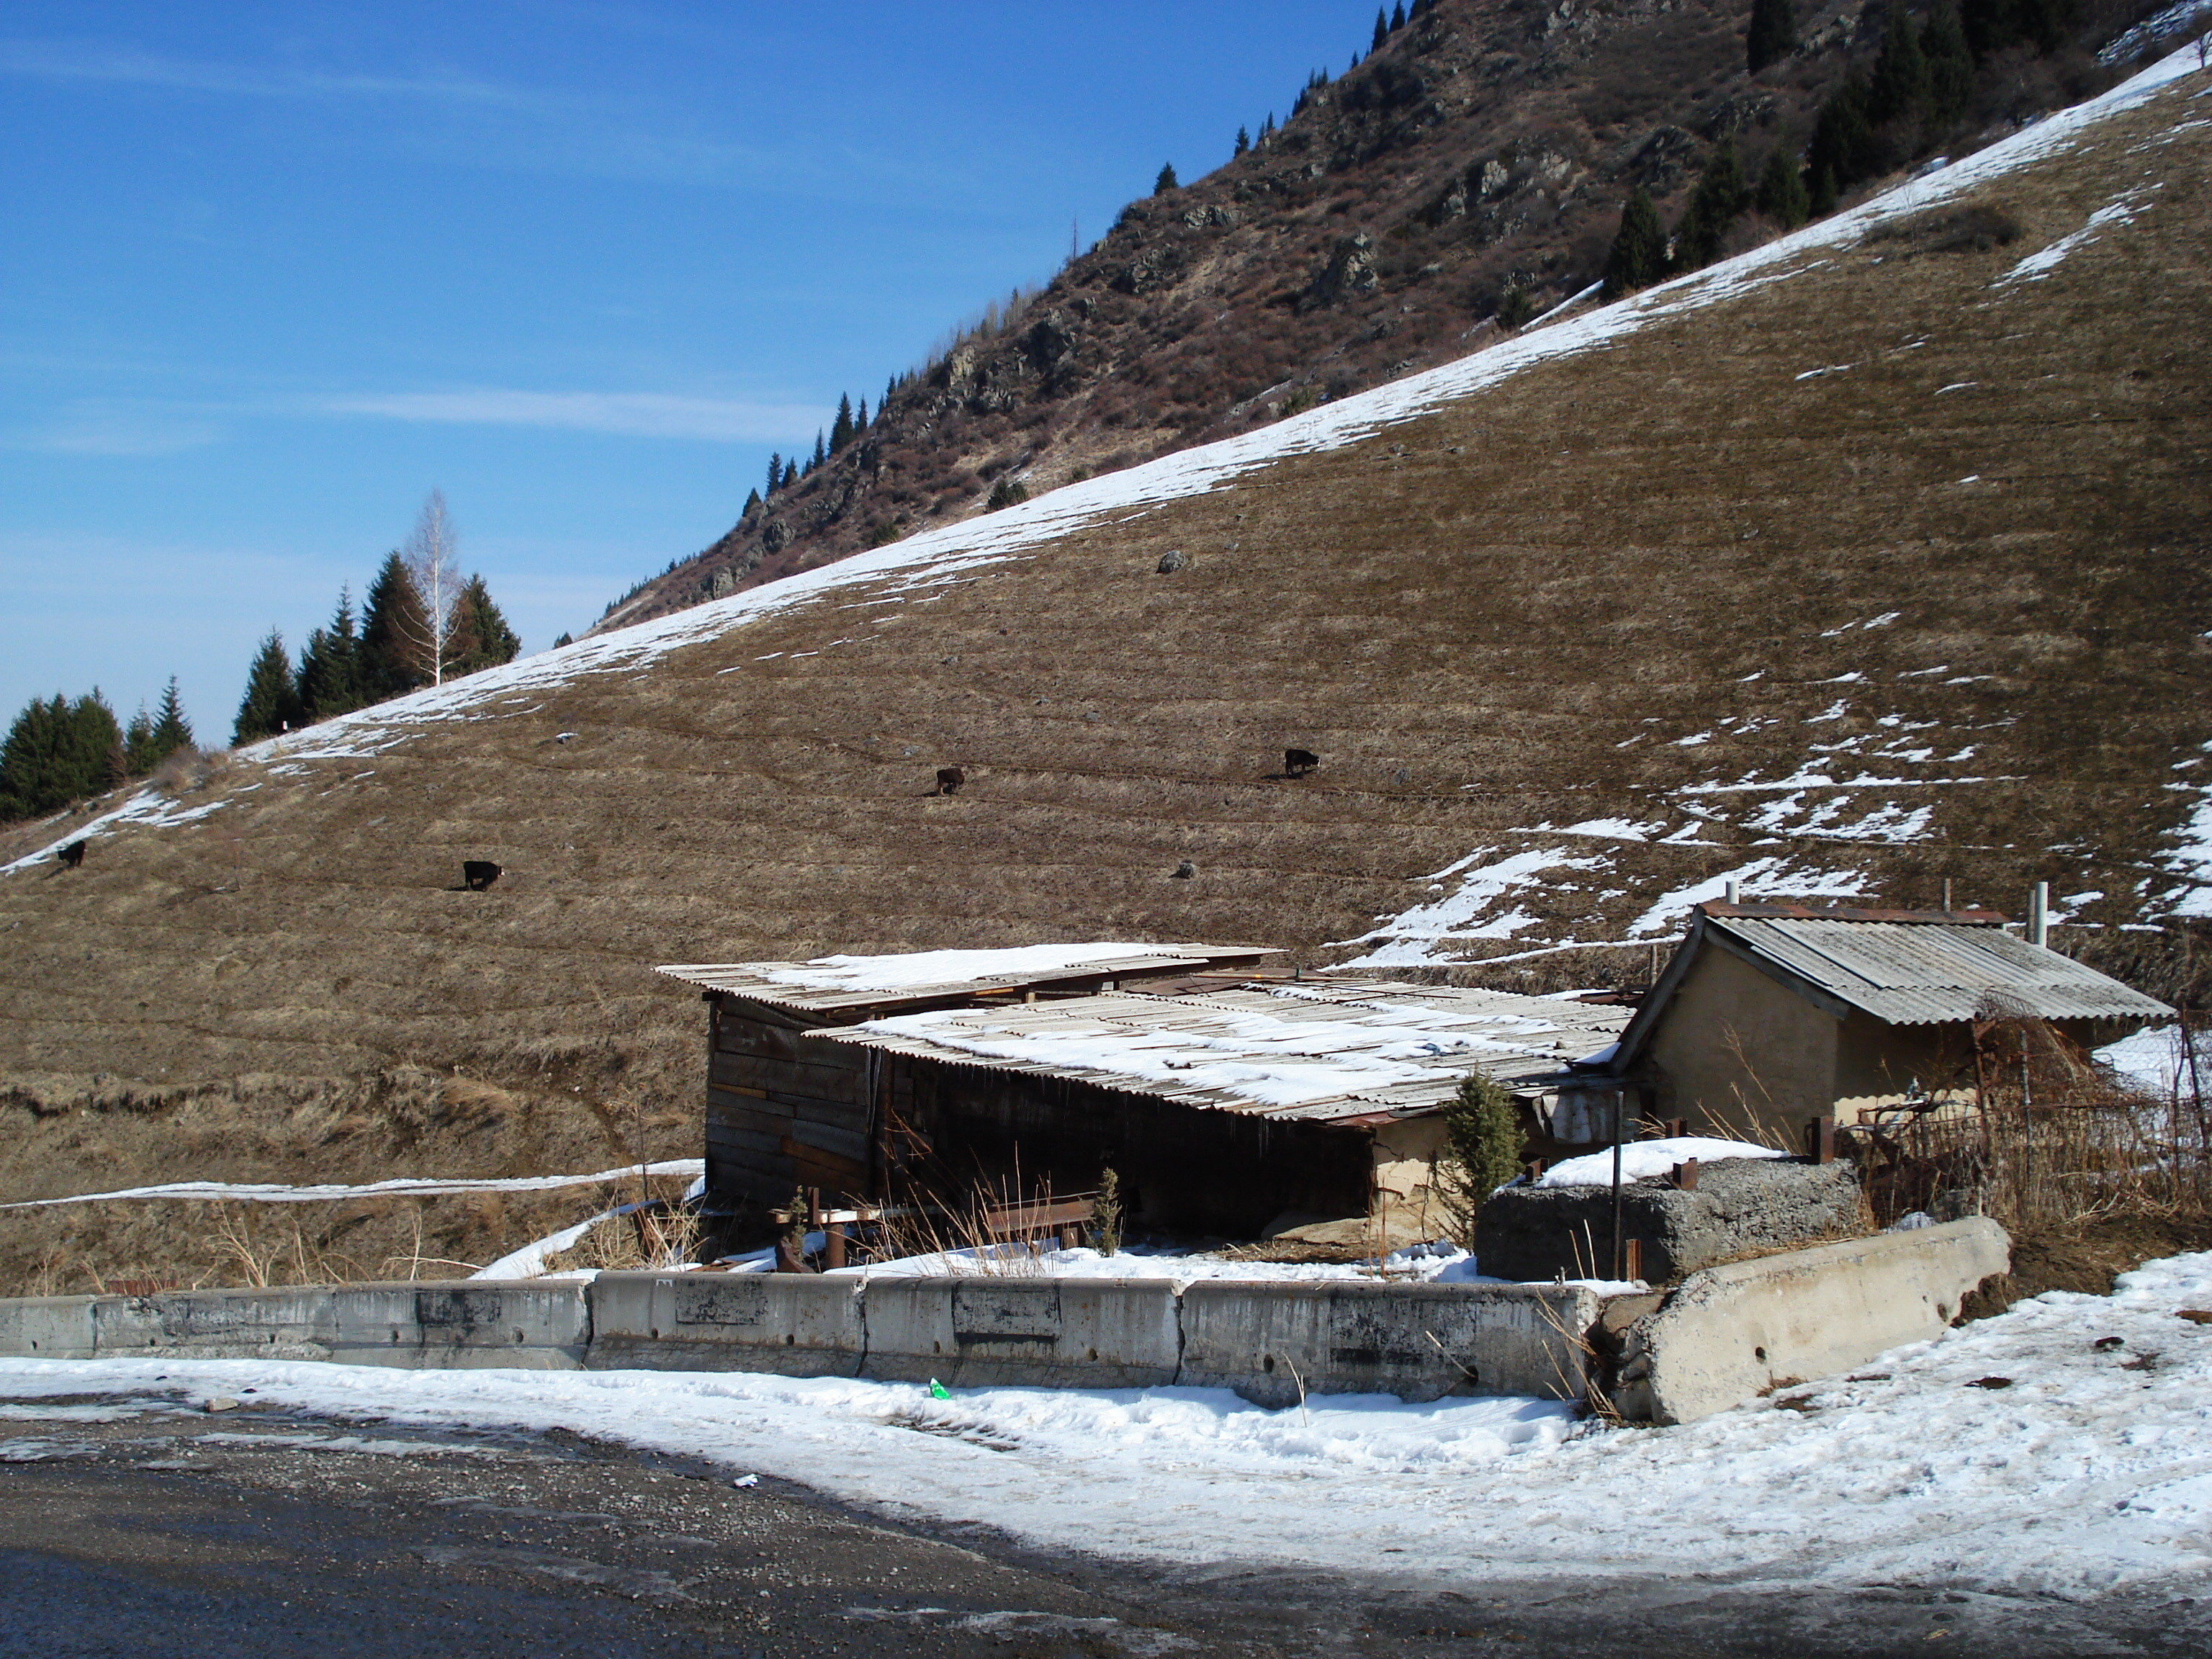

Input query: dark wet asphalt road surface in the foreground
[0,1395,2212,1659]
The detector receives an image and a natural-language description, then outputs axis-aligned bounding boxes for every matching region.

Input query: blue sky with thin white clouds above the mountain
[0,0,1374,741]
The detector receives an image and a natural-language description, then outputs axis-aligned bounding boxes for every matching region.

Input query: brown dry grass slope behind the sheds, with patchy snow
[0,73,2212,1283]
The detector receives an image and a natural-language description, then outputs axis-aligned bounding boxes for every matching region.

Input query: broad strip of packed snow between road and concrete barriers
[0,1254,2212,1597]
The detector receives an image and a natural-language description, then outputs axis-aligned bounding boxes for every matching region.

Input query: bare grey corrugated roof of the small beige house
[1701,907,2172,1026]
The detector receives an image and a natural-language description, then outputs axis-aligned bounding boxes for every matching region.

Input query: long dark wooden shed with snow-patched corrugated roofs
[670,947,1628,1236]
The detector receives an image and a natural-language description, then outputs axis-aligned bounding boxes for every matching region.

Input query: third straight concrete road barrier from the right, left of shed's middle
[584,1274,867,1376]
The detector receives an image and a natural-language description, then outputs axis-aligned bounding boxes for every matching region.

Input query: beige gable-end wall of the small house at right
[1648,949,1843,1139]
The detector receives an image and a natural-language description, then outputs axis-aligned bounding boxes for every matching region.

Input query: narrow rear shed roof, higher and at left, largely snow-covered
[655,945,1272,1015]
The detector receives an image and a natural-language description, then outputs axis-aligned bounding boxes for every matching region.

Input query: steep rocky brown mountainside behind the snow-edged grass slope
[597,0,2141,631]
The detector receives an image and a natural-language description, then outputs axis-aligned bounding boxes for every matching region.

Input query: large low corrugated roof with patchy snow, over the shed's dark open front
[809,980,1628,1122]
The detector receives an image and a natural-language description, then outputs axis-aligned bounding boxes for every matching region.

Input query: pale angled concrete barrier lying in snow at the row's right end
[1615,1217,2010,1422]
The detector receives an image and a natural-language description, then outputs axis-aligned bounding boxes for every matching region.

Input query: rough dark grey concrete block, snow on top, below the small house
[1475,1157,1867,1285]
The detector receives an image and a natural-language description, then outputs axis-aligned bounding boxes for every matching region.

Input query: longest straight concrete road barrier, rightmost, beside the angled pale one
[1177,1279,1599,1407]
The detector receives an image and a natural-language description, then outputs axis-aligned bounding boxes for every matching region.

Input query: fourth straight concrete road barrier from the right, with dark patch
[325,1279,590,1372]
